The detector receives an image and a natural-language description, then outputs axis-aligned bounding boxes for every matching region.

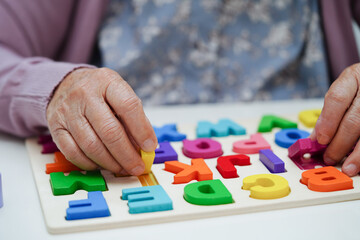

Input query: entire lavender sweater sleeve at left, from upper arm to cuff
[0,0,95,137]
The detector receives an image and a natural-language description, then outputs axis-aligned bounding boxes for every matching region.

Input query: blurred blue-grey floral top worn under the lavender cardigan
[99,0,328,105]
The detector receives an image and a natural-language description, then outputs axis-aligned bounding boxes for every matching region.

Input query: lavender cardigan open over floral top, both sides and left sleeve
[0,0,360,137]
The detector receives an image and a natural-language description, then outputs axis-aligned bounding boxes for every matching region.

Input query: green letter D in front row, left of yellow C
[184,179,234,205]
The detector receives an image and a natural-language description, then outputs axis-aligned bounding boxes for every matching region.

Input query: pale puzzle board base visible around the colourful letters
[26,116,360,233]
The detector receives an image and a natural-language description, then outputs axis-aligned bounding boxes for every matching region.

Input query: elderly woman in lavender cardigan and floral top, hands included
[0,0,360,176]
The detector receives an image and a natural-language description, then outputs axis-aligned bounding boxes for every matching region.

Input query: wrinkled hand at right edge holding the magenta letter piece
[311,64,360,176]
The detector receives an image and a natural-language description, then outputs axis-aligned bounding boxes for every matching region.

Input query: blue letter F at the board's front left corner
[66,191,110,220]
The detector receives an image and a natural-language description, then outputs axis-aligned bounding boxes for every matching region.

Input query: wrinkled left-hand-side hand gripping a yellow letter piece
[46,68,157,175]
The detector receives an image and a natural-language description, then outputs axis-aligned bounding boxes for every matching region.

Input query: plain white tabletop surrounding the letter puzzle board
[0,100,360,240]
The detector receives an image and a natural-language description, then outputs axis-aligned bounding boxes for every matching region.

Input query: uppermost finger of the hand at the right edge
[315,66,358,144]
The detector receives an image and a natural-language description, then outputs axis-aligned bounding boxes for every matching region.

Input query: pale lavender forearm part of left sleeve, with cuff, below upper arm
[0,44,90,137]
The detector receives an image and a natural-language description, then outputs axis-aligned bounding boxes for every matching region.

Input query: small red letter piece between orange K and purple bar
[216,154,251,178]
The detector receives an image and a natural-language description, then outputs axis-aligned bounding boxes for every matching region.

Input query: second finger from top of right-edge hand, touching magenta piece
[324,96,360,165]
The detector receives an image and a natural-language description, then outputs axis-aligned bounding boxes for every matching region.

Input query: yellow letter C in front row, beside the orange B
[242,174,290,199]
